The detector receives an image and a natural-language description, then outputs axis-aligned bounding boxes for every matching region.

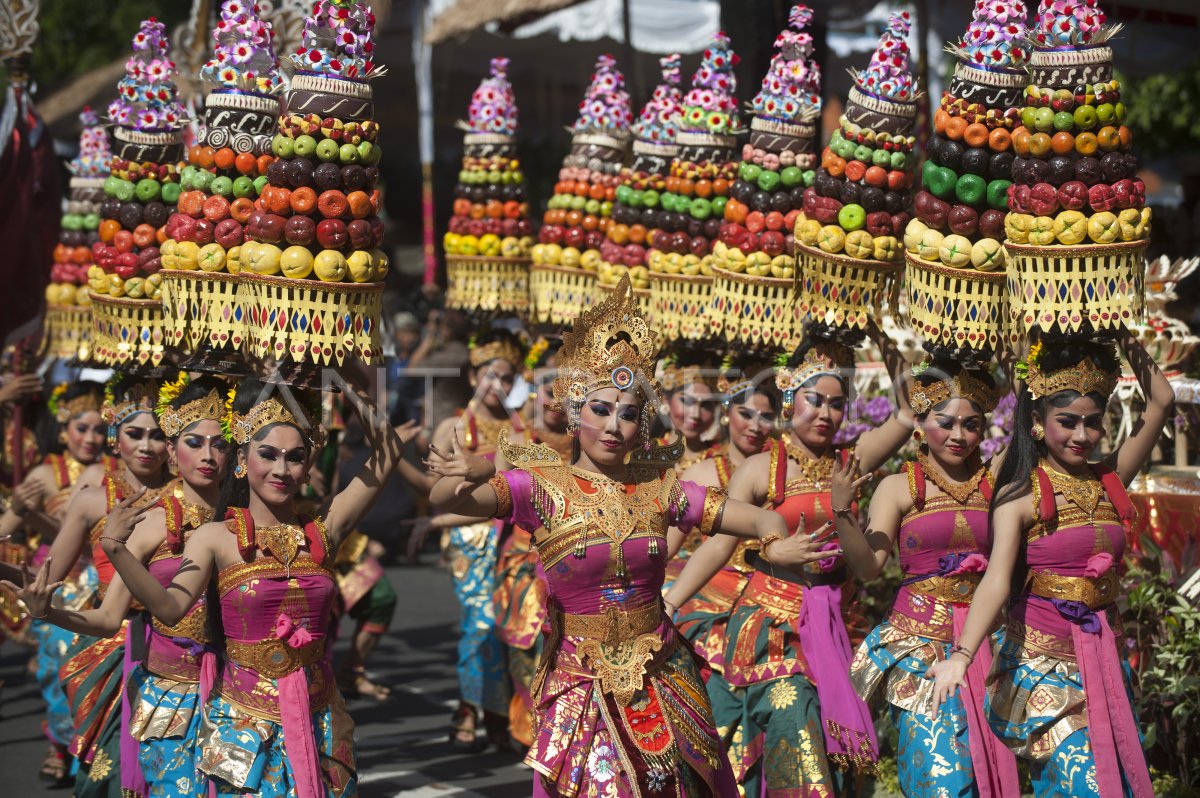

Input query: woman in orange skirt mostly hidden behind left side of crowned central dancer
[496,338,575,748]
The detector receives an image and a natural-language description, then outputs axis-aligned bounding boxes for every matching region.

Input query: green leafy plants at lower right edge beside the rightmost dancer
[1122,538,1200,798]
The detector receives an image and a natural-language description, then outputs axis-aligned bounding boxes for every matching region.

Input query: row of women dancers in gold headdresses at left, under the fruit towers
[5,377,416,798]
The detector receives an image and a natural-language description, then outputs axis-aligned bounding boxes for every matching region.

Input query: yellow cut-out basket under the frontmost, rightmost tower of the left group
[239,272,384,366]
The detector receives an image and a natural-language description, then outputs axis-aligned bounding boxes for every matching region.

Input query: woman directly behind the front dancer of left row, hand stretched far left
[6,376,232,798]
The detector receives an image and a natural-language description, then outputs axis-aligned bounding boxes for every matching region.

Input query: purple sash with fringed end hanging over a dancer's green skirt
[796,584,880,762]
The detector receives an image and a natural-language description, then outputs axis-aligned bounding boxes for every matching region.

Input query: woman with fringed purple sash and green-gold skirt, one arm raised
[667,329,912,796]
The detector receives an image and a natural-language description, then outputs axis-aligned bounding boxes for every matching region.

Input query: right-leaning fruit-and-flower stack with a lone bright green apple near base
[796,12,916,262]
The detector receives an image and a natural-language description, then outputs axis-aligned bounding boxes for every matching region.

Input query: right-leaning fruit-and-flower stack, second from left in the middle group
[533,55,633,278]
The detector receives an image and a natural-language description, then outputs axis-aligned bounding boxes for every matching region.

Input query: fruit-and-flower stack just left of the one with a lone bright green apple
[720,5,821,278]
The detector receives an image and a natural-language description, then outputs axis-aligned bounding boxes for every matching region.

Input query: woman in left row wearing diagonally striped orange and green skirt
[46,377,170,796]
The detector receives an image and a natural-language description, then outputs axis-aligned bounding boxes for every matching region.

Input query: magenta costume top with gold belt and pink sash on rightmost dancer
[1008,464,1152,798]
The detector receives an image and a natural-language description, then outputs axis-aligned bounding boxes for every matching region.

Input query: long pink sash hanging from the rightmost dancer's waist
[1070,611,1154,798]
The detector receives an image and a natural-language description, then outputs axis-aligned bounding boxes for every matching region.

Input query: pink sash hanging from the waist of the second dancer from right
[952,605,1021,798]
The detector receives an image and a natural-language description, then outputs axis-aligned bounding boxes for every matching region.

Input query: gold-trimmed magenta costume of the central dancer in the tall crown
[492,445,737,798]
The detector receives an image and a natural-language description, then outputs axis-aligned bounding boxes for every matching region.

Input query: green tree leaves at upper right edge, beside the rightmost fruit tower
[1121,59,1200,157]
